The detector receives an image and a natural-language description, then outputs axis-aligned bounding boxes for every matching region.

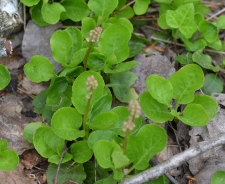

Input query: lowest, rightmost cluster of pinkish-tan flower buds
[123,100,141,132]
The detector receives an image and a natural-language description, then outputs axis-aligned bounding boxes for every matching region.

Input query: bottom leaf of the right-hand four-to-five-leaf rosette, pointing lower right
[177,103,210,126]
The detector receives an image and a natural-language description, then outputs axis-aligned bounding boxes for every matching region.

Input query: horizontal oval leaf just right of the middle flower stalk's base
[88,112,119,130]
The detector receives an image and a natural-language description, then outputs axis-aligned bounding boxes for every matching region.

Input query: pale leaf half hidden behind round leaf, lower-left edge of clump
[23,122,46,143]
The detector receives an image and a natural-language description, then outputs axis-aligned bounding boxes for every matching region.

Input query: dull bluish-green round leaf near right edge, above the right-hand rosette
[202,73,223,95]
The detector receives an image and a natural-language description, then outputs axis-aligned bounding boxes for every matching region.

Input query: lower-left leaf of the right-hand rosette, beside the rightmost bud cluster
[140,91,173,123]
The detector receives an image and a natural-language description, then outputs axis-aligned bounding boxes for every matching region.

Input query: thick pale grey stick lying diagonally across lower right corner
[120,134,225,184]
